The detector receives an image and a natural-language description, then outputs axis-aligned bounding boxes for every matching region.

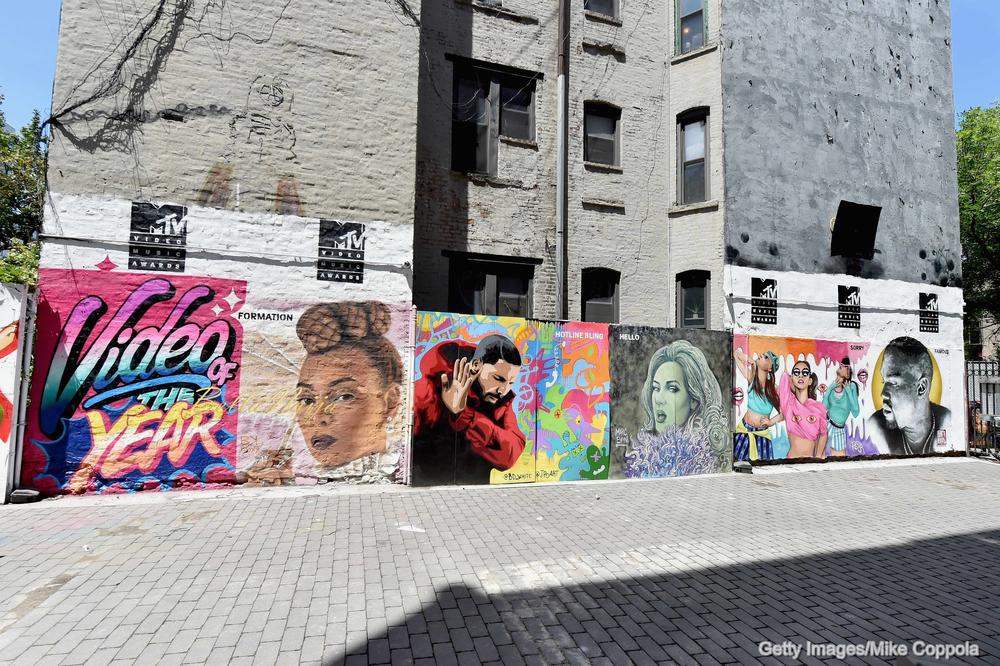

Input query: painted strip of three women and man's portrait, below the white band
[733,335,961,460]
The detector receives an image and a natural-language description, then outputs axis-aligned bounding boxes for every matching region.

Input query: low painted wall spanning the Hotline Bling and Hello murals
[412,312,732,485]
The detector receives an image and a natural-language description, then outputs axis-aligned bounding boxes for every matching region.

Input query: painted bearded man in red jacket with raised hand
[413,335,525,485]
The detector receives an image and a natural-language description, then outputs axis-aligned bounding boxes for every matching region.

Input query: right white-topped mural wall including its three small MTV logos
[726,266,966,460]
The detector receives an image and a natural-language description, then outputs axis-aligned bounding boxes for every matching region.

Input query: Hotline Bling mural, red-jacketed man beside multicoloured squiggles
[411,312,610,485]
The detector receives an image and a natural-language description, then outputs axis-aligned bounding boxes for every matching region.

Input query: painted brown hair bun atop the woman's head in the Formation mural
[296,301,391,354]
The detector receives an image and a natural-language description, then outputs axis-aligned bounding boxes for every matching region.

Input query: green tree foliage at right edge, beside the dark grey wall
[958,102,1000,352]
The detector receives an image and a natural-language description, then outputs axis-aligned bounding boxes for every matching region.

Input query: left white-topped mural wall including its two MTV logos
[21,195,413,494]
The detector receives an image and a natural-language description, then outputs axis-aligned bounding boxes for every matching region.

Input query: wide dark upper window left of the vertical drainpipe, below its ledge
[447,56,542,176]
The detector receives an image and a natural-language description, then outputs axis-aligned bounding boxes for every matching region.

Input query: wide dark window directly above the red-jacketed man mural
[444,251,541,319]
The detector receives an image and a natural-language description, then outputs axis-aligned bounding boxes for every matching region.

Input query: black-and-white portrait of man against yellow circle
[867,337,951,455]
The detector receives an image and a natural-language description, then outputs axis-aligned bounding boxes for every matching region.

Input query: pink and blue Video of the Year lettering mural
[22,269,246,493]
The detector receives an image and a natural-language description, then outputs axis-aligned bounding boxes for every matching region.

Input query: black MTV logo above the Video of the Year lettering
[128,202,187,273]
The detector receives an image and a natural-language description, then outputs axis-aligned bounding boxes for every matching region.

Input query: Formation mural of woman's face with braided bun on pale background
[237,299,412,485]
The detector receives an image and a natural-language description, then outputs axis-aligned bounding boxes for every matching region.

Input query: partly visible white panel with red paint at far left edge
[0,284,27,501]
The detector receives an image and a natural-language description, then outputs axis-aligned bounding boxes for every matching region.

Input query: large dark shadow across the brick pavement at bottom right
[324,531,1000,666]
